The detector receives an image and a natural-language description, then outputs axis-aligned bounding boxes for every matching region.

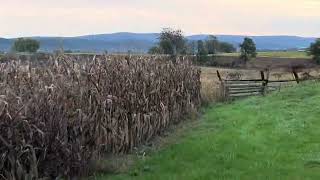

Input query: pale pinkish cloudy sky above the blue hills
[0,0,320,38]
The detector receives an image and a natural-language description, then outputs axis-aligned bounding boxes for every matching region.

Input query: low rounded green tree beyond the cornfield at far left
[12,38,40,53]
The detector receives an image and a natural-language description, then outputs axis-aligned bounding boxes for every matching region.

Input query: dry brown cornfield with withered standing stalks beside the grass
[0,55,201,180]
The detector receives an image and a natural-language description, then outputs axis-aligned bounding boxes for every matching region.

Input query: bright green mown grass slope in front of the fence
[96,84,320,180]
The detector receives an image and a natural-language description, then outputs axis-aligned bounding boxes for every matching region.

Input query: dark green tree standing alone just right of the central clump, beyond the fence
[240,37,257,61]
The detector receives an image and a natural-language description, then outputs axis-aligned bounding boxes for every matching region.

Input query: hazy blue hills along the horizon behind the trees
[0,32,315,53]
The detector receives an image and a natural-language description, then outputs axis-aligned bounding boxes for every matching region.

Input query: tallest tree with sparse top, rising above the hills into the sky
[159,28,187,55]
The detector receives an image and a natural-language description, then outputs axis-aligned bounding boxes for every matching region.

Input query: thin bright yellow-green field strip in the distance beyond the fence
[221,51,311,58]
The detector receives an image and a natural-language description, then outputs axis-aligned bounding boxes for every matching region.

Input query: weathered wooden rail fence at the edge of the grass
[217,70,312,99]
